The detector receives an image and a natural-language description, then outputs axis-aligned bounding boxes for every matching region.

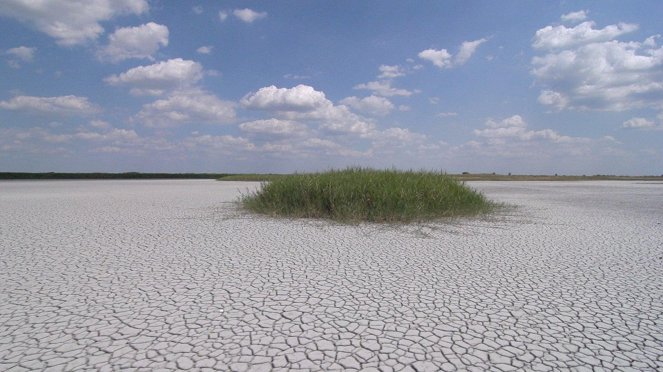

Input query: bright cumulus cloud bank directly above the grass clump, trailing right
[233,85,430,161]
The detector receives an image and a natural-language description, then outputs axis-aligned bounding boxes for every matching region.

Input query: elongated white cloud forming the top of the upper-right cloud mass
[532,21,638,49]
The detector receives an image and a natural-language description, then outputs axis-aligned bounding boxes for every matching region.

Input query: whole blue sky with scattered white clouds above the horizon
[0,0,663,175]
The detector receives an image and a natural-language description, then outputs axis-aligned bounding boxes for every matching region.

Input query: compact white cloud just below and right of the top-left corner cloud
[97,22,169,62]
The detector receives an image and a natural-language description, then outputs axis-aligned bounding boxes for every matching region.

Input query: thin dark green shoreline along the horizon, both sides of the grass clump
[0,172,663,182]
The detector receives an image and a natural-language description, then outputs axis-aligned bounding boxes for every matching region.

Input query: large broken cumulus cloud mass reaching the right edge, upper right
[531,16,663,111]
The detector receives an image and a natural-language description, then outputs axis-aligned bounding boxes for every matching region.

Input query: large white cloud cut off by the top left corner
[0,0,149,46]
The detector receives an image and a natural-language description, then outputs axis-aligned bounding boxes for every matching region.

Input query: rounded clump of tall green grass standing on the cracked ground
[241,168,494,222]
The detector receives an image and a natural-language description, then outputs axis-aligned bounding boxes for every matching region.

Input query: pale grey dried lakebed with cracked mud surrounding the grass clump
[0,180,663,371]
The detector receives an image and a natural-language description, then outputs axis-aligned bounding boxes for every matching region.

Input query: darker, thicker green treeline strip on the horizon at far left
[0,172,229,180]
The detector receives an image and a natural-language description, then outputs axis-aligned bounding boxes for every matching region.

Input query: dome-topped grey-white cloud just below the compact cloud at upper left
[133,90,235,128]
